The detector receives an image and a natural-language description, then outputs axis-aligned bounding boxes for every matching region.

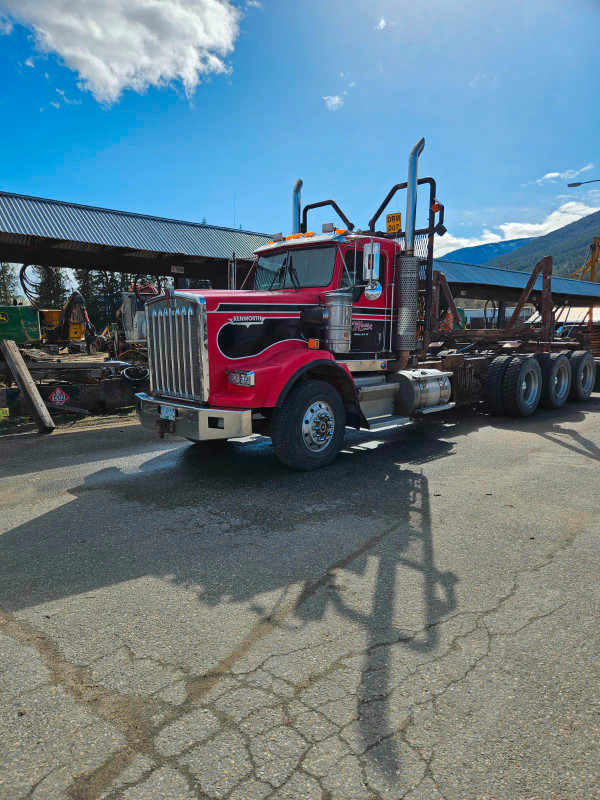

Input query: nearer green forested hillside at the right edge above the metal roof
[482,211,600,277]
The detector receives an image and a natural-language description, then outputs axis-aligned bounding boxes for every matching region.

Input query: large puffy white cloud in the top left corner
[0,0,240,103]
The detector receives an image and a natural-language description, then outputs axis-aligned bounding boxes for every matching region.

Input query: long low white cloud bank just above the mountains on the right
[435,200,600,257]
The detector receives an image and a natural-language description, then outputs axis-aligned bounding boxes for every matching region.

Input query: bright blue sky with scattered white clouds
[0,0,600,255]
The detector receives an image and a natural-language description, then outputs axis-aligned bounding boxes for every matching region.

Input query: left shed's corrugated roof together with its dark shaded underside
[0,192,271,287]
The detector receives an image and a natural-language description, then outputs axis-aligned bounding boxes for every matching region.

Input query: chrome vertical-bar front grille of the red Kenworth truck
[146,294,209,402]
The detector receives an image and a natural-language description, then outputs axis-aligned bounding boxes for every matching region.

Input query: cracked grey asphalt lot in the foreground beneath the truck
[0,395,600,800]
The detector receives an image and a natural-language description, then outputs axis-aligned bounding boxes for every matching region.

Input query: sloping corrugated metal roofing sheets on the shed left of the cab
[0,192,271,259]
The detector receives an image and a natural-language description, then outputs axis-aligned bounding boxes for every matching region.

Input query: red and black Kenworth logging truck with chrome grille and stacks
[136,139,596,470]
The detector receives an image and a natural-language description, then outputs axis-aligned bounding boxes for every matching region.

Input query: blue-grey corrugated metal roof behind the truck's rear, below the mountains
[434,258,600,301]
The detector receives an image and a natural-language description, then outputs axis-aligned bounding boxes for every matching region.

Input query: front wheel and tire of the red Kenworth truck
[271,379,346,470]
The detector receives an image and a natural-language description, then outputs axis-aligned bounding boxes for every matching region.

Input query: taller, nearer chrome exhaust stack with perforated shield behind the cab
[394,139,425,362]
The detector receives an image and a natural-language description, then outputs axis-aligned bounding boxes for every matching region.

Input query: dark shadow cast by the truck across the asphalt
[0,424,458,781]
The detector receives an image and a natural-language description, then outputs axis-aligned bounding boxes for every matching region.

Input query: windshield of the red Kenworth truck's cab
[254,247,335,291]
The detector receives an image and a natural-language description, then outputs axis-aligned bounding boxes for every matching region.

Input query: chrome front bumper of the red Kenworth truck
[135,392,252,442]
